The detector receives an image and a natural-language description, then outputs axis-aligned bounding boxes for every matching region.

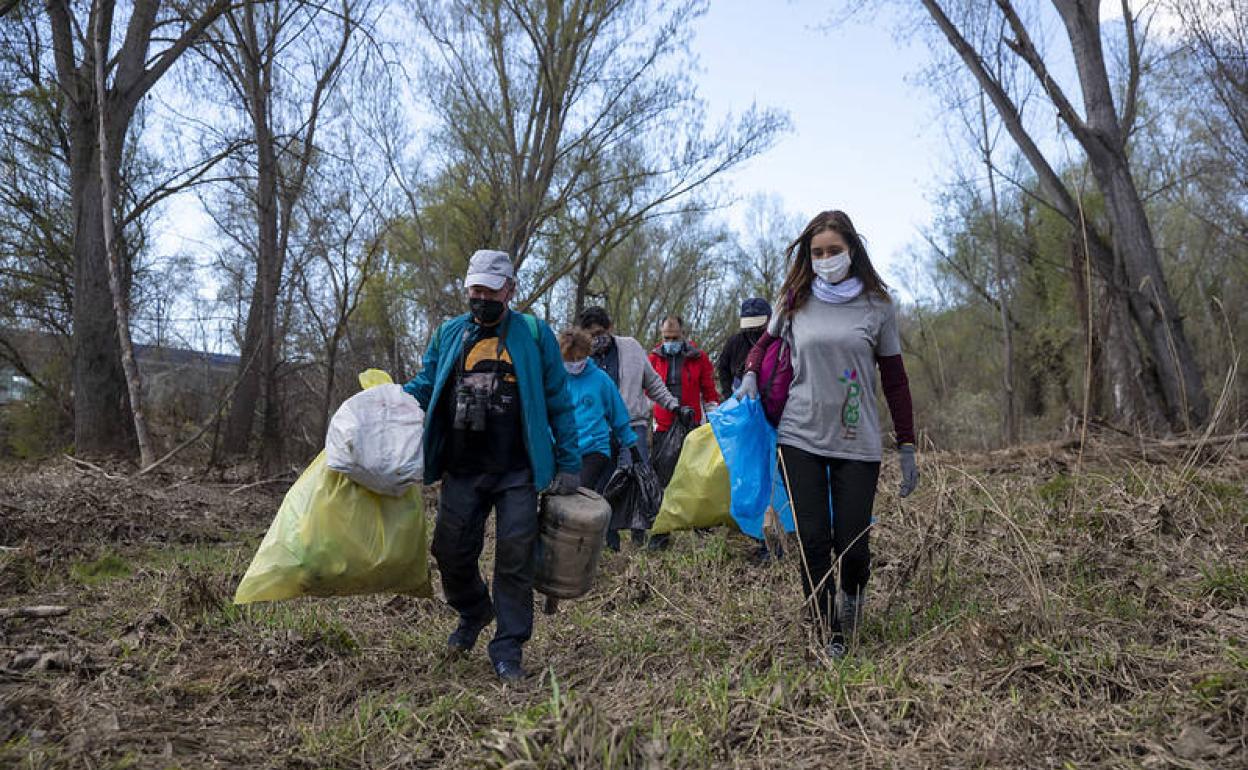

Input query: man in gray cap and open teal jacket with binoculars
[403,250,580,683]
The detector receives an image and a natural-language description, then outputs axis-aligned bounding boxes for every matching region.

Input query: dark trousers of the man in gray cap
[432,468,538,663]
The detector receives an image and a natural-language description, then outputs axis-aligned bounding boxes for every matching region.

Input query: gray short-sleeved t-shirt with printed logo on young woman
[769,292,901,461]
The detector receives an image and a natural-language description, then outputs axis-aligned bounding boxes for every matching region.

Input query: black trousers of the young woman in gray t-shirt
[780,444,880,633]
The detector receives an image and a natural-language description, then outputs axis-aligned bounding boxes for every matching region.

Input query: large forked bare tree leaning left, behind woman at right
[921,0,1208,431]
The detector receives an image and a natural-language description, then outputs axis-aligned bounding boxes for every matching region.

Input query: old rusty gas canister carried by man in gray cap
[533,487,612,613]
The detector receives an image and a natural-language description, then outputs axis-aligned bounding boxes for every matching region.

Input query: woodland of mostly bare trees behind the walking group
[0,0,1248,472]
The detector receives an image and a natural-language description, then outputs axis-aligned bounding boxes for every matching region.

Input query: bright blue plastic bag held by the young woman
[706,398,794,539]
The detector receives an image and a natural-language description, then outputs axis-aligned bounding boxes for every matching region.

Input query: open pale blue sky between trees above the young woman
[693,0,952,288]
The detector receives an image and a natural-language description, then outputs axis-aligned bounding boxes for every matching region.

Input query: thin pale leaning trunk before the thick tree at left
[92,0,156,468]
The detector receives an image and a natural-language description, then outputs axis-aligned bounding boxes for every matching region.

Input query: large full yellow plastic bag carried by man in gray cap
[235,369,433,604]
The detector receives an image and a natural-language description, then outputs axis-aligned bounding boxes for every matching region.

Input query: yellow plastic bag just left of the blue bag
[650,424,736,534]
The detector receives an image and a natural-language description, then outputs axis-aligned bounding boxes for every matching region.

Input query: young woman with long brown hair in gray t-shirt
[738,211,919,658]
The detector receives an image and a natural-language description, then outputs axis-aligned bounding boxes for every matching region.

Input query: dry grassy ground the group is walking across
[0,447,1248,769]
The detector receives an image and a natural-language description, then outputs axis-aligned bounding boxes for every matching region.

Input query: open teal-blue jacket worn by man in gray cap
[403,311,580,489]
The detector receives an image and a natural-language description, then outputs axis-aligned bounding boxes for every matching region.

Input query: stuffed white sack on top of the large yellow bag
[324,384,424,497]
